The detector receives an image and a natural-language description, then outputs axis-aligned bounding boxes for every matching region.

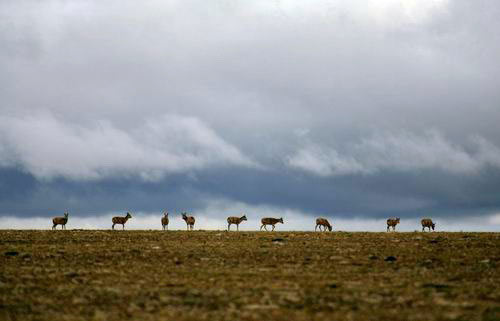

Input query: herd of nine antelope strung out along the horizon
[52,212,436,232]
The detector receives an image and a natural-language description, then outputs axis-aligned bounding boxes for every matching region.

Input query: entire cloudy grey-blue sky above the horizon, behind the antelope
[0,0,500,231]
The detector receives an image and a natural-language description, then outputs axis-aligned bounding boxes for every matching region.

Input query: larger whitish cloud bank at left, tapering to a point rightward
[0,114,255,180]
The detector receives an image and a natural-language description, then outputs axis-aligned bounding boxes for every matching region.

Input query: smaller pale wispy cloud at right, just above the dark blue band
[287,130,500,176]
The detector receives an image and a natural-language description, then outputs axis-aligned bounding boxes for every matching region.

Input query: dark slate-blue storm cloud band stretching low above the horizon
[0,168,500,219]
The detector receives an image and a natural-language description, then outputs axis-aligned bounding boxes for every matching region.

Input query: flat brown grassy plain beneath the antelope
[0,230,500,321]
